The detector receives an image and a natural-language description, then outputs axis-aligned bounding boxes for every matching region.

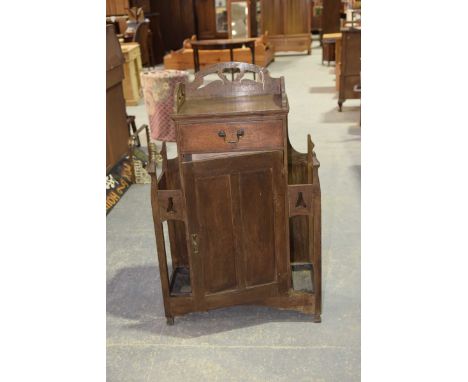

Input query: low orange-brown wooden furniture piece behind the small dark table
[164,32,274,70]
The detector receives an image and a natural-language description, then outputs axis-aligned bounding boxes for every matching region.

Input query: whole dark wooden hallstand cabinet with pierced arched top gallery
[150,62,321,324]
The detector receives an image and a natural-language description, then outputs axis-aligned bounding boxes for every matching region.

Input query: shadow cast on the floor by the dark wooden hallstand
[107,266,312,338]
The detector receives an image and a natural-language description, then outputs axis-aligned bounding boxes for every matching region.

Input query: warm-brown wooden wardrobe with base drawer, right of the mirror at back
[261,0,312,54]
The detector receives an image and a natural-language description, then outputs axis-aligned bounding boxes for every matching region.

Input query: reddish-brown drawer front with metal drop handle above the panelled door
[178,120,284,153]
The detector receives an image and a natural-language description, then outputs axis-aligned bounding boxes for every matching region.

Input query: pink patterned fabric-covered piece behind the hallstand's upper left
[141,70,188,142]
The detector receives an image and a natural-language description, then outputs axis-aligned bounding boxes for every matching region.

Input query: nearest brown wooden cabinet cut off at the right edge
[337,28,361,111]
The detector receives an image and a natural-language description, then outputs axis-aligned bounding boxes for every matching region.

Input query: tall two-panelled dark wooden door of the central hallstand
[182,151,287,308]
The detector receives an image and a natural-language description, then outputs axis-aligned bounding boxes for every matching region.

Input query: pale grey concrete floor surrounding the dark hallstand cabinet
[107,42,361,382]
